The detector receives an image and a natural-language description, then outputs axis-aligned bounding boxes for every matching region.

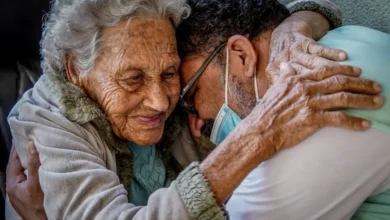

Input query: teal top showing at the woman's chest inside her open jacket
[129,143,170,206]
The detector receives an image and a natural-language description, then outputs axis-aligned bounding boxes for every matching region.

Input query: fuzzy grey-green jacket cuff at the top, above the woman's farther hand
[286,0,342,29]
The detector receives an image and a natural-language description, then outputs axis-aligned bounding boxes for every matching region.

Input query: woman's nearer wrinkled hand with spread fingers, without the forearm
[243,63,384,157]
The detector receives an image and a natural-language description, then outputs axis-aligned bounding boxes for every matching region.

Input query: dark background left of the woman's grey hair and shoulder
[0,0,49,219]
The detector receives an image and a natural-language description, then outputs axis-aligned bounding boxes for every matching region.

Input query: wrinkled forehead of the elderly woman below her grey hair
[97,19,180,73]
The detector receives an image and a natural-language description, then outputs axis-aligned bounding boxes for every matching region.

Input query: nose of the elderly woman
[145,81,169,112]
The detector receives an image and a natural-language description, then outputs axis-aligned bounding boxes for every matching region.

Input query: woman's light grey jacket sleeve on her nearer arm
[8,89,209,220]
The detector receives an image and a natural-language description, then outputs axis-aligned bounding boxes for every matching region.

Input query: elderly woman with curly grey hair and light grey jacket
[4,0,382,220]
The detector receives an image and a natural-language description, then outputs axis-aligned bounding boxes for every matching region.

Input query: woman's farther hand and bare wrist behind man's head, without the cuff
[267,11,348,82]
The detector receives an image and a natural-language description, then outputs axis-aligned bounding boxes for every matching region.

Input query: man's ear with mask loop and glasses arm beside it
[226,35,257,78]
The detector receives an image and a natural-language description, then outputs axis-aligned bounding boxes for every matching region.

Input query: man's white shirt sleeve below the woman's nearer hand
[227,128,390,220]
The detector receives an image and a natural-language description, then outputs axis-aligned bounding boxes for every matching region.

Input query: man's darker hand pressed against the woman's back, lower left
[7,142,47,220]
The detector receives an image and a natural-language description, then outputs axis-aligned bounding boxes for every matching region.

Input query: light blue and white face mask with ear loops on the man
[210,49,261,145]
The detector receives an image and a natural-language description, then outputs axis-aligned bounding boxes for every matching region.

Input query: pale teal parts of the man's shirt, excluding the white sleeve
[319,26,390,220]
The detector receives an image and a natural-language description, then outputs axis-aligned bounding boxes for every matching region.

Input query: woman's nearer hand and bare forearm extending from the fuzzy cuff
[200,64,383,204]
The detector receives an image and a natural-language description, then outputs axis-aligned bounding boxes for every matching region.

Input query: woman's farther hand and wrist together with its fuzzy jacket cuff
[267,0,348,83]
